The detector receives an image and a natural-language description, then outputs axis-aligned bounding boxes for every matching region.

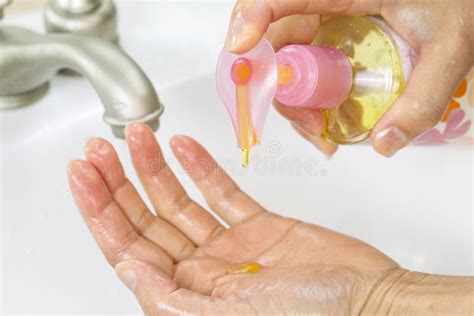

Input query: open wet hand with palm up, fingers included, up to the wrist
[68,124,399,314]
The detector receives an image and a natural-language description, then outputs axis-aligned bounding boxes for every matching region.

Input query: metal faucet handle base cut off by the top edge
[44,0,118,43]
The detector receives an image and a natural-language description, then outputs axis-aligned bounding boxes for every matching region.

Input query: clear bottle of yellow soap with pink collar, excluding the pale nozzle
[276,17,417,144]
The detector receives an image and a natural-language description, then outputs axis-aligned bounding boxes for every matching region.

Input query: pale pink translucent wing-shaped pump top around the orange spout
[216,40,277,147]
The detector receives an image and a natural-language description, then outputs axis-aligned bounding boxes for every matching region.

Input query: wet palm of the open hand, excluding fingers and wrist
[175,213,397,315]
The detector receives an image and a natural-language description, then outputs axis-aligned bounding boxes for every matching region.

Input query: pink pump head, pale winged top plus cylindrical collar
[216,39,352,148]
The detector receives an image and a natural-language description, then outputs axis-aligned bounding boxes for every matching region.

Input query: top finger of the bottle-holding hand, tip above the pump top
[226,0,382,53]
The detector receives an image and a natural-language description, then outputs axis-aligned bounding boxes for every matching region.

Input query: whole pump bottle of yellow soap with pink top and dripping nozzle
[216,17,417,165]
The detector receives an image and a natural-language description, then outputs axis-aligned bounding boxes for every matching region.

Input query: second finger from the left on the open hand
[85,138,196,262]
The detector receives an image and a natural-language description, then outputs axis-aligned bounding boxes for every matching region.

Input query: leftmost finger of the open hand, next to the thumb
[68,160,173,273]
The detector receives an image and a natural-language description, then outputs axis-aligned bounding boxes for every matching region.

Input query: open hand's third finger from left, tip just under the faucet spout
[125,123,224,245]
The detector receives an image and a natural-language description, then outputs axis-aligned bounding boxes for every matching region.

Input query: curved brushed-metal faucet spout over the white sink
[0,0,163,138]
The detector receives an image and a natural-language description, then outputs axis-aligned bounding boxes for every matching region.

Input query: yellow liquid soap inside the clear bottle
[313,16,405,144]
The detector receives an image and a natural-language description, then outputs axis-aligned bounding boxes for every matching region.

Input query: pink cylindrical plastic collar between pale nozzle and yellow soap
[275,45,352,109]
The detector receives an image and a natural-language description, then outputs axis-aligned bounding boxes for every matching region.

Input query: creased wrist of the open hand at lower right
[361,269,474,315]
